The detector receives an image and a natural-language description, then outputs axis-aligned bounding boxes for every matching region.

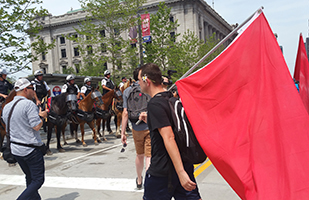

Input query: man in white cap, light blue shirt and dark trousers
[2,78,47,200]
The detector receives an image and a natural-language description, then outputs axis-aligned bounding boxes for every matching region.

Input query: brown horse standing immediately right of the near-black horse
[71,90,102,146]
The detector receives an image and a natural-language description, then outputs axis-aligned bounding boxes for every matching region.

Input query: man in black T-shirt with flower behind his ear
[138,63,201,200]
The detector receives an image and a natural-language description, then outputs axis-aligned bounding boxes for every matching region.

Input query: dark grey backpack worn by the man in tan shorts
[127,84,150,123]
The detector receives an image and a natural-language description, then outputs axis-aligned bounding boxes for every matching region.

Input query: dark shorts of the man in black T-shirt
[143,165,201,200]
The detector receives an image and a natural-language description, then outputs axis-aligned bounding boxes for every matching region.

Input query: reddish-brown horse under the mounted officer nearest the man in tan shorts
[96,90,116,141]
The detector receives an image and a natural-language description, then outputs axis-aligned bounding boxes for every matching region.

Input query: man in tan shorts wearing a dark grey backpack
[121,68,151,189]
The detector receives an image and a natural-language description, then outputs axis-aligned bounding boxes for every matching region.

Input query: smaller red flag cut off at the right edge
[294,34,309,113]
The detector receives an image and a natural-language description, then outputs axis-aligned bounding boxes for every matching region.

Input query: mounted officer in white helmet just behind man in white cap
[31,69,51,105]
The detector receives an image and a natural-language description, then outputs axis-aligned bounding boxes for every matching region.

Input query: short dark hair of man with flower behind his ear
[139,63,162,86]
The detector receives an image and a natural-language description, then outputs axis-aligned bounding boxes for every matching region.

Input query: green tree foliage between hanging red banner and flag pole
[144,3,223,82]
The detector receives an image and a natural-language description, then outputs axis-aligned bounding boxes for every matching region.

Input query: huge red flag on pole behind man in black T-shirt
[176,12,309,200]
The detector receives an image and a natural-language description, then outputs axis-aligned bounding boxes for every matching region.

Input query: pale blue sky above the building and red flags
[35,0,309,77]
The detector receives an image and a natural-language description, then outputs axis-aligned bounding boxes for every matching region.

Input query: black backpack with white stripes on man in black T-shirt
[168,97,207,164]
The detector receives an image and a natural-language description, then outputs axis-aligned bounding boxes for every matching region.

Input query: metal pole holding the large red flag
[168,6,264,91]
